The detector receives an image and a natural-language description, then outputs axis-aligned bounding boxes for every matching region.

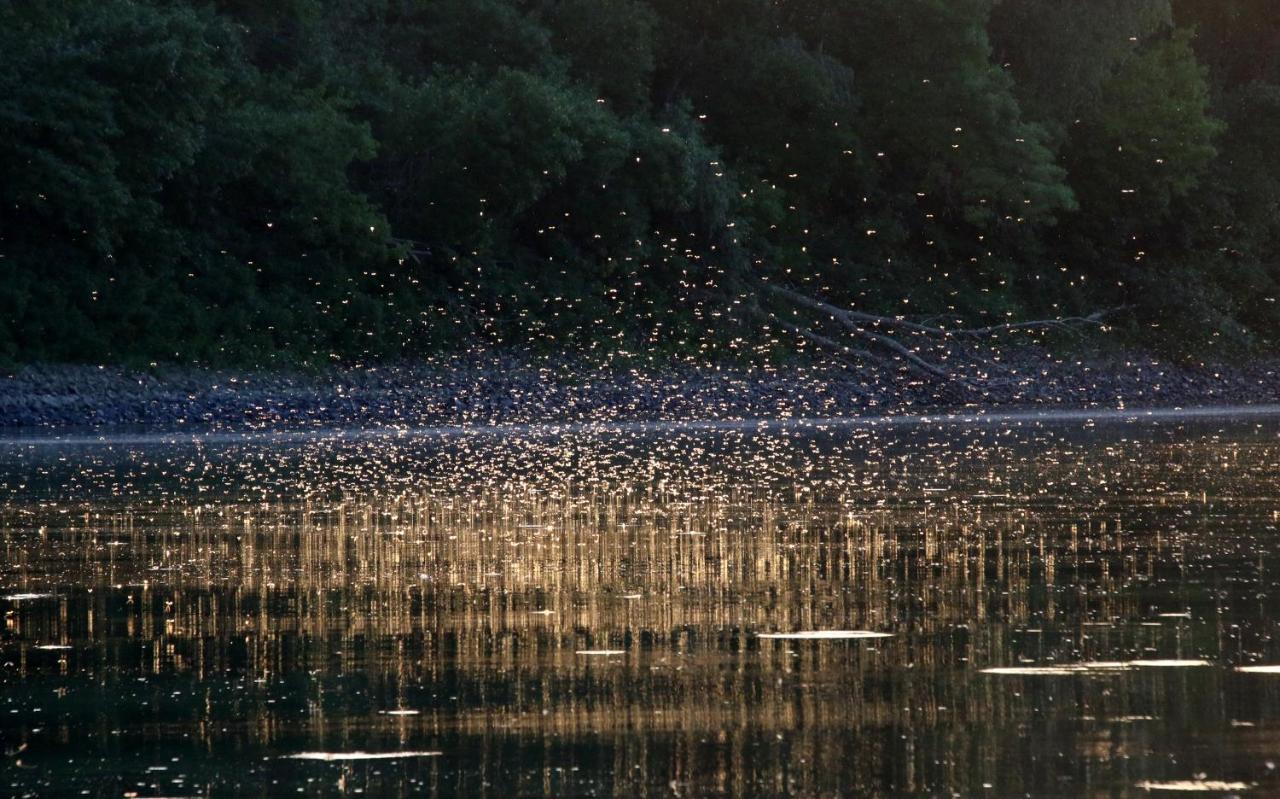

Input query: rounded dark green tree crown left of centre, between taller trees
[375,68,626,252]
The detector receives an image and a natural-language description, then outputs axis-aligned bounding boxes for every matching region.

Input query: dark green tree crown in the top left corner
[0,1,232,256]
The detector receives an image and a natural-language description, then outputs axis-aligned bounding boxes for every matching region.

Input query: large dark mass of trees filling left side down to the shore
[0,0,390,360]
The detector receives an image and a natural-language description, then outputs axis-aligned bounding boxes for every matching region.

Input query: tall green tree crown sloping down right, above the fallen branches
[793,0,1074,232]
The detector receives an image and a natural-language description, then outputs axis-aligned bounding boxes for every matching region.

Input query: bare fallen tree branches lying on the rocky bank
[765,286,1123,391]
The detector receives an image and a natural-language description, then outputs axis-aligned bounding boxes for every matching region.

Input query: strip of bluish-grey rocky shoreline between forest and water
[0,348,1280,430]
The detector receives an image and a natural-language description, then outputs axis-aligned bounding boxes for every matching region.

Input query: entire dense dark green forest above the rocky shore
[0,0,1280,362]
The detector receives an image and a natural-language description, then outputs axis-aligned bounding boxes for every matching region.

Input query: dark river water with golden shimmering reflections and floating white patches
[0,412,1280,798]
